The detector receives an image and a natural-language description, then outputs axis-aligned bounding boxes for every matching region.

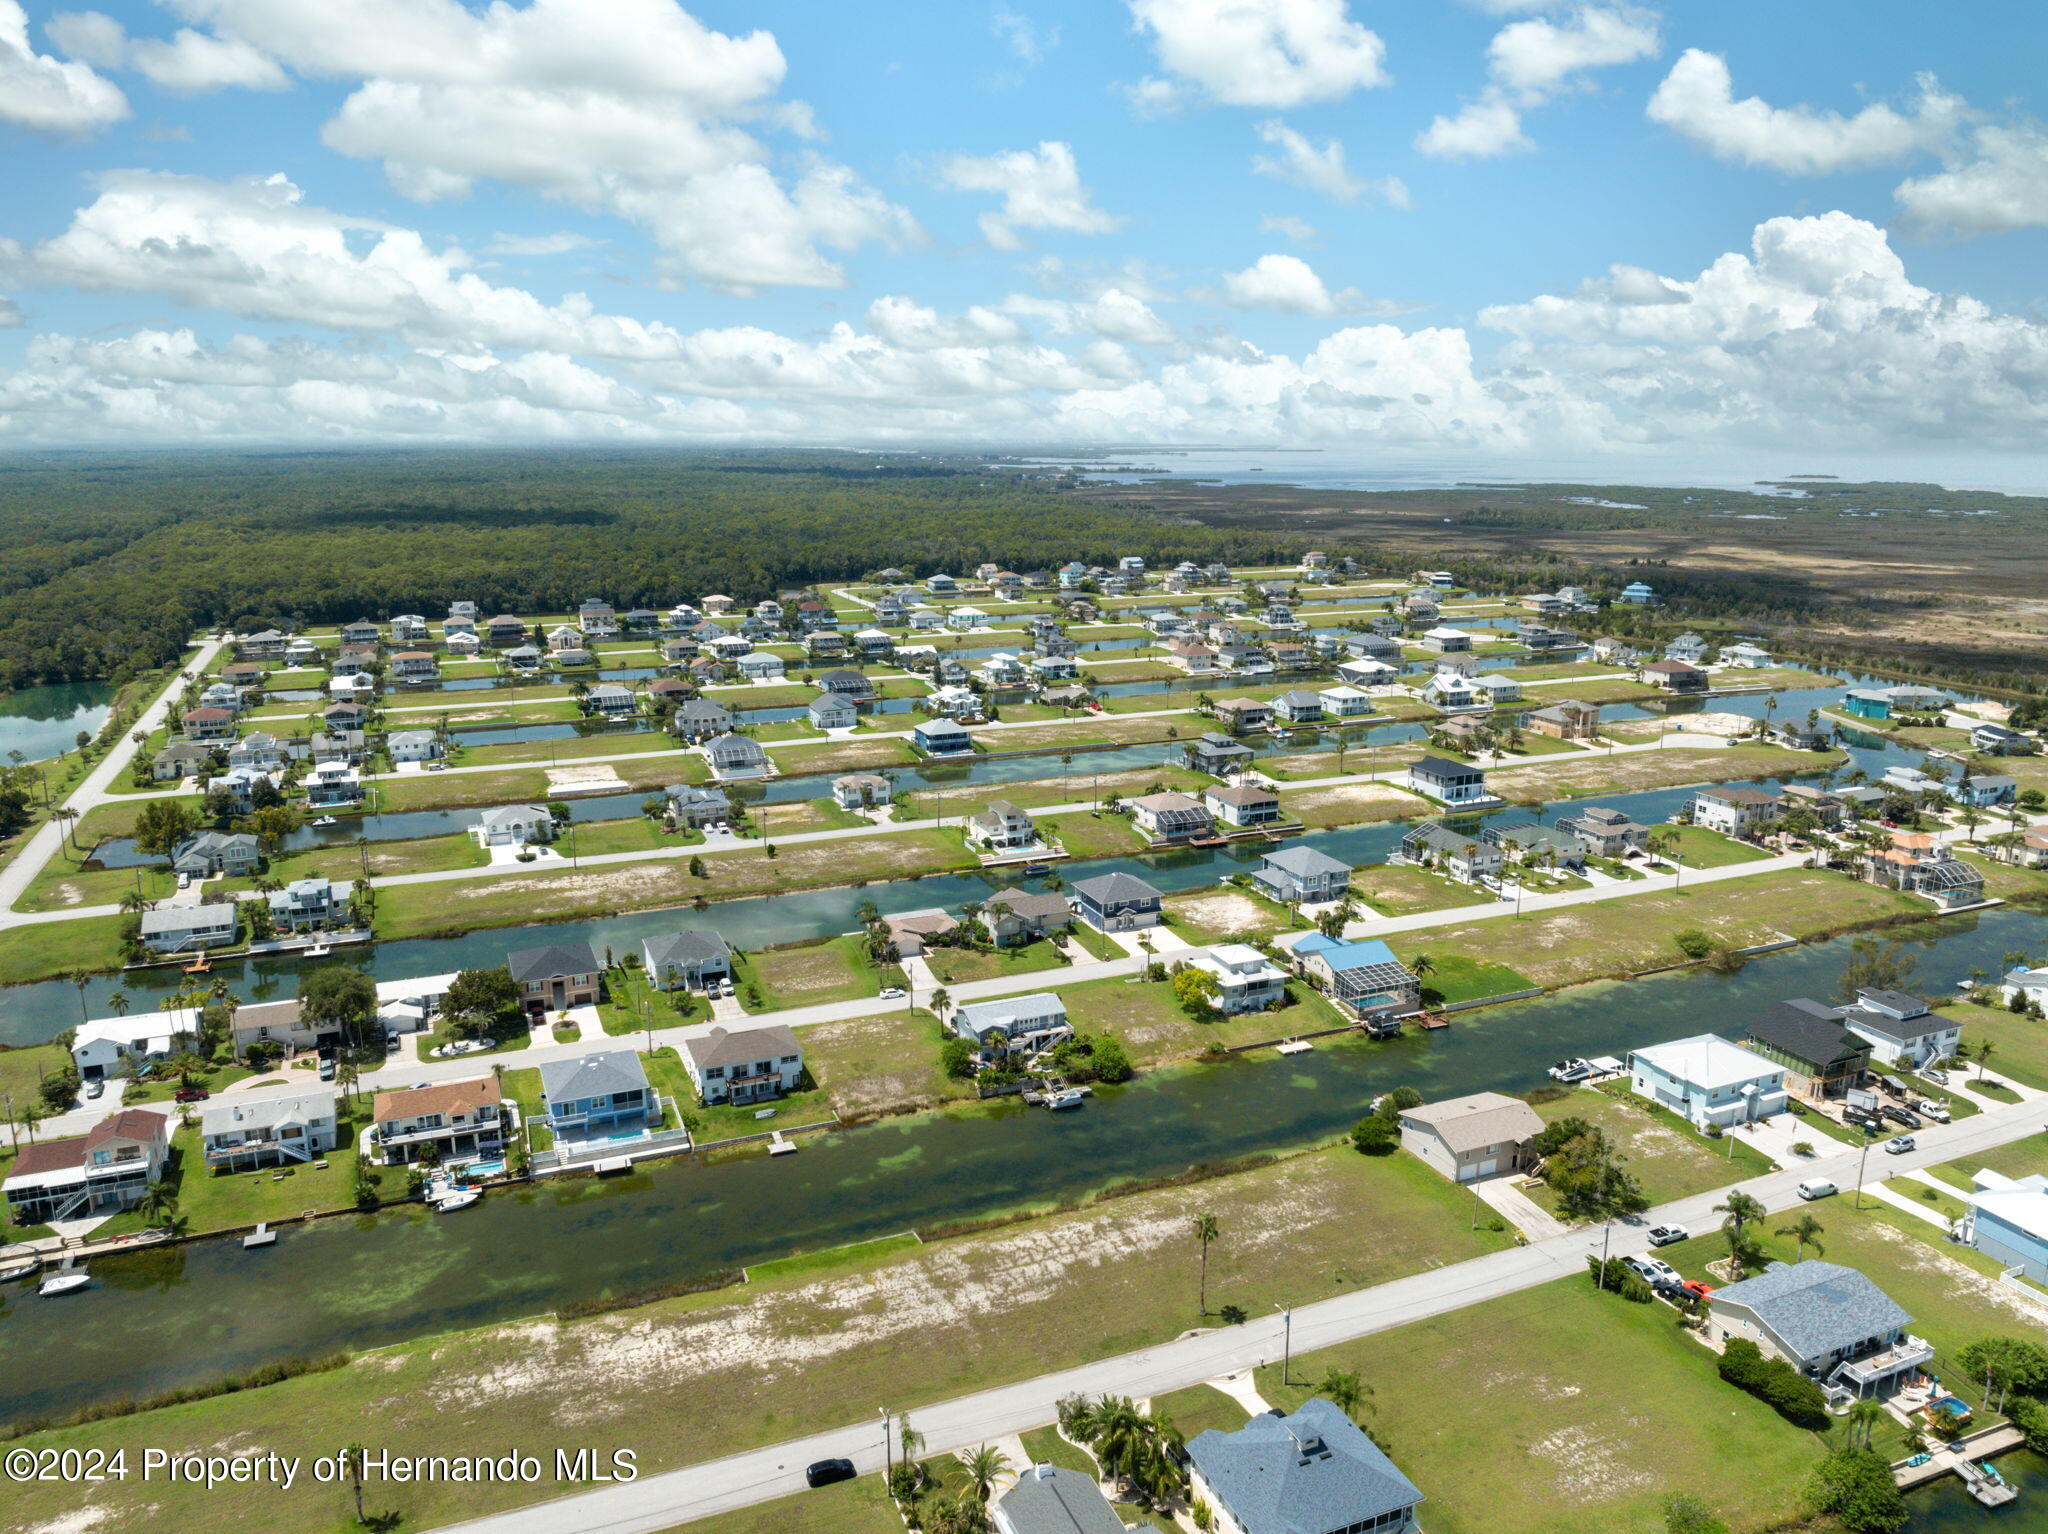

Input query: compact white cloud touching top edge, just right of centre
[1128,0,1389,106]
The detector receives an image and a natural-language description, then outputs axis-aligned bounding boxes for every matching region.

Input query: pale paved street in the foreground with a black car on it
[428,1102,2044,1534]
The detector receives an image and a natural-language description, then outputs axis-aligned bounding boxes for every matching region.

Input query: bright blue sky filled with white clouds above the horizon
[0,0,2048,461]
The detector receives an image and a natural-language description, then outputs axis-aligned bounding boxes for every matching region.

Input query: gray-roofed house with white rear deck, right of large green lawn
[1706,1258,1933,1399]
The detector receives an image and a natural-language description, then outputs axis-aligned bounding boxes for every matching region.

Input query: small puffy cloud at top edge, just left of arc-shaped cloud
[1415,4,1663,160]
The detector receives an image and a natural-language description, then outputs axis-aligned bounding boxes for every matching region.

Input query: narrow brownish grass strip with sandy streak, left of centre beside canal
[376,829,975,944]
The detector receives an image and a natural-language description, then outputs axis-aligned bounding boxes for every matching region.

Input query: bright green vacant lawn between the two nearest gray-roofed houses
[1260,1278,1821,1534]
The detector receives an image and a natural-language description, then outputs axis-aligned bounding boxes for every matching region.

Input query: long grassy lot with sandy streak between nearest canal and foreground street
[8,1149,1536,1534]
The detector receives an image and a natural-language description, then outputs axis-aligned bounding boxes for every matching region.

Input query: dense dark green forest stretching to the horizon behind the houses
[0,451,1303,688]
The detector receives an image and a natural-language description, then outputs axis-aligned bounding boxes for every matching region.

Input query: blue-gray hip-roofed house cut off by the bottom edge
[1188,1397,1423,1534]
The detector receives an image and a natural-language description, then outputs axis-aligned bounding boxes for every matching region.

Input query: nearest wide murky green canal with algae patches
[0,909,2048,1419]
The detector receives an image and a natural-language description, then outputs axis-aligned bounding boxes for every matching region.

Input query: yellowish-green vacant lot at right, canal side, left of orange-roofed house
[1395,868,1927,987]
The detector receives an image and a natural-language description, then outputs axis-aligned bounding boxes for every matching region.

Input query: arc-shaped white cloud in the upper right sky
[1647,47,1964,176]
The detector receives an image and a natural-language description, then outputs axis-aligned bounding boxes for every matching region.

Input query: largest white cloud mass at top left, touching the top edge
[61,0,918,291]
